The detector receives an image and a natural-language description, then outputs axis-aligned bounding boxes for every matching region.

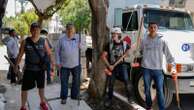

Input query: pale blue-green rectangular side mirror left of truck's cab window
[114,8,123,27]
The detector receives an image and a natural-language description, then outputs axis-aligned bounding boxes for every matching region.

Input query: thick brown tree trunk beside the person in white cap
[88,0,108,98]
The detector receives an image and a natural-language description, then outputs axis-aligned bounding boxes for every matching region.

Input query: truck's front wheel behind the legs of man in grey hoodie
[134,73,173,108]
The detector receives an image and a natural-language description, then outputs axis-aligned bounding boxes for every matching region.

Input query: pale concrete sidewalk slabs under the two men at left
[3,83,92,110]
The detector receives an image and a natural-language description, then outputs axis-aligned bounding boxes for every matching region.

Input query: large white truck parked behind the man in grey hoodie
[107,4,194,107]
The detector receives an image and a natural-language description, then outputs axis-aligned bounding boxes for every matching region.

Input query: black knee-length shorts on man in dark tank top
[22,70,45,91]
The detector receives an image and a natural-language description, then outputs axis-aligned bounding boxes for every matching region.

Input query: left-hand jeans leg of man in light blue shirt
[60,67,70,100]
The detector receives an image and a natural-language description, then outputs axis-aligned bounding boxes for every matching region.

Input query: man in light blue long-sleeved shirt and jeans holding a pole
[55,23,82,104]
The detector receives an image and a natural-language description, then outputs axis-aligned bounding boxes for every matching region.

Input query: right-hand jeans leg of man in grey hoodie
[153,70,165,110]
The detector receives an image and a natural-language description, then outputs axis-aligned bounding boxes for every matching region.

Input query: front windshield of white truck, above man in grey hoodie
[143,9,193,30]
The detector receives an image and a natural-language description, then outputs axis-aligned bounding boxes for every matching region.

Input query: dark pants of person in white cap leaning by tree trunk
[108,64,133,100]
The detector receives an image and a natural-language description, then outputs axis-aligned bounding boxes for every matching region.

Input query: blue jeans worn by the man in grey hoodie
[143,68,165,110]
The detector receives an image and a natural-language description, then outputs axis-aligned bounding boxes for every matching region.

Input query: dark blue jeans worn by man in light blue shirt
[60,65,81,99]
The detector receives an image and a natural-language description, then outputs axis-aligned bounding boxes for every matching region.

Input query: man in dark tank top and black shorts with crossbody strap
[15,22,54,110]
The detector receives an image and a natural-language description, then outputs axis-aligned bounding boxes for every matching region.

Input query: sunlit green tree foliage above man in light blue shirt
[59,0,91,31]
